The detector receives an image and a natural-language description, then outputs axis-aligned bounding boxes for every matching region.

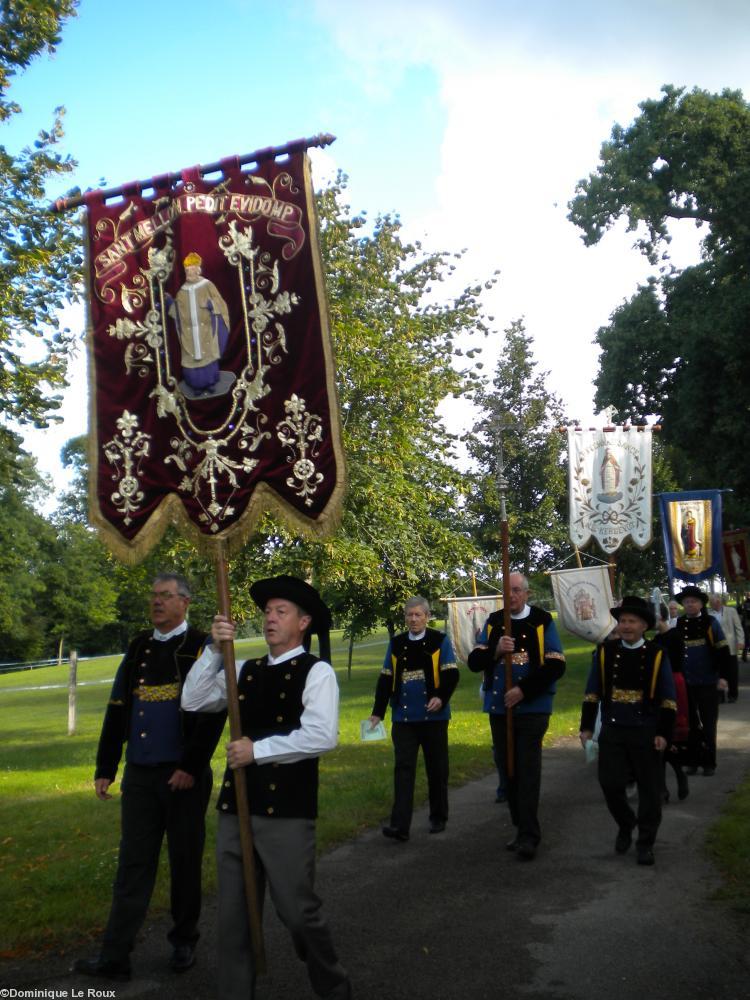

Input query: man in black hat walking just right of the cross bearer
[579,597,677,865]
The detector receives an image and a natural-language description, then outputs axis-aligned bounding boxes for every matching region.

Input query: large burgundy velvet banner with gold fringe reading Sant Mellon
[85,152,344,562]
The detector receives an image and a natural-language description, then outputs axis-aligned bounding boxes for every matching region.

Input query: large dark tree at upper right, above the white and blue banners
[570,87,750,524]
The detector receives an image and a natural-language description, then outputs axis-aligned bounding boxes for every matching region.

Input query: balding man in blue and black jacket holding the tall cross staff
[468,573,565,861]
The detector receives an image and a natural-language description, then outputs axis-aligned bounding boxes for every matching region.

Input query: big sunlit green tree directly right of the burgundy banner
[226,182,494,635]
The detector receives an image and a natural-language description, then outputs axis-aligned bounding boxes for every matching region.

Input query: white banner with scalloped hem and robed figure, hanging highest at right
[568,427,651,553]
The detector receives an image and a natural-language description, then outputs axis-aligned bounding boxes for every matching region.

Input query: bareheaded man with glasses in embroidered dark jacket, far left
[74,573,226,980]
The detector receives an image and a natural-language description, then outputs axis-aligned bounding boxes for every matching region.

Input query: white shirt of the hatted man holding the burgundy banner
[182,645,339,764]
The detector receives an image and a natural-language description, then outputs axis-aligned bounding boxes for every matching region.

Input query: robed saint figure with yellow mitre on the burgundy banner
[167,252,235,399]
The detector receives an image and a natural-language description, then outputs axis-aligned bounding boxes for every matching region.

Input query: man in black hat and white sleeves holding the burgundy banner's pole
[182,576,351,1000]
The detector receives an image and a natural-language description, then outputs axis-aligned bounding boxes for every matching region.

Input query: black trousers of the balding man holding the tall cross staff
[490,712,549,847]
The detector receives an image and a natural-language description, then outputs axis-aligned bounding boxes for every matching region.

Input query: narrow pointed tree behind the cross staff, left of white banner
[469,320,567,577]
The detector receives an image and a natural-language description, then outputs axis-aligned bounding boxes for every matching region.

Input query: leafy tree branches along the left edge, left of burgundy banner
[0,0,81,446]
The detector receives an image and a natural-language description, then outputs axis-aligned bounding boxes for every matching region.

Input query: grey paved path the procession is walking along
[0,667,750,1000]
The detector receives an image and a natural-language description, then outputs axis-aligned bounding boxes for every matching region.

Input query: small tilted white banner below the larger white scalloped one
[550,566,617,642]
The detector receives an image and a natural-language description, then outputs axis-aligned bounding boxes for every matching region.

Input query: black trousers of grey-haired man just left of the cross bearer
[391,719,448,833]
